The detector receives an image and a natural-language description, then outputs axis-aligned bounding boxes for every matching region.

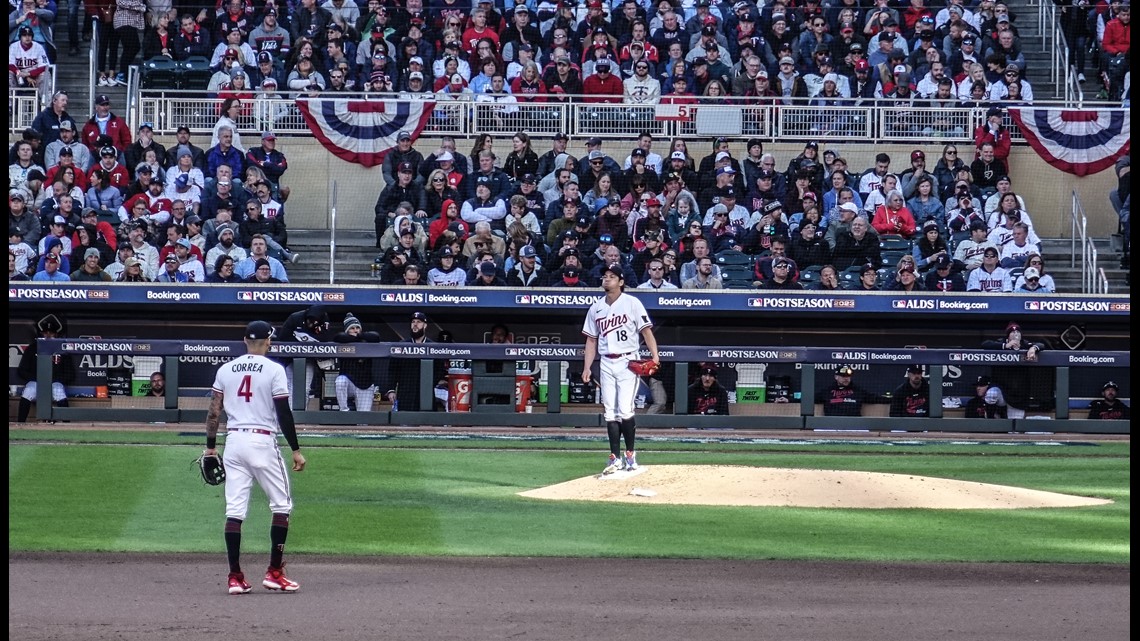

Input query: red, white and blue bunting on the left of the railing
[296,98,434,167]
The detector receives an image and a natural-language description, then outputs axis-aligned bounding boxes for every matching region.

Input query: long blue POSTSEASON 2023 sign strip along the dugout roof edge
[8,283,1132,318]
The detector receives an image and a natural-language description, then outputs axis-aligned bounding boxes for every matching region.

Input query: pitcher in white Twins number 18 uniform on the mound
[581,263,661,474]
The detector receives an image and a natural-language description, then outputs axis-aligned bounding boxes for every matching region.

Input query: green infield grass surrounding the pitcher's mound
[8,431,1131,563]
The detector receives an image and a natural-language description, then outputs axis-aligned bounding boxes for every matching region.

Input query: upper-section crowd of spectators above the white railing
[9,0,1129,111]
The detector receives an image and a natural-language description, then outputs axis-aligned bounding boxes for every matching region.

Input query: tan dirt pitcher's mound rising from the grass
[519,465,1112,510]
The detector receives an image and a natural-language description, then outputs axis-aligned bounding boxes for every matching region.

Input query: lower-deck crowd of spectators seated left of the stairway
[8,86,300,283]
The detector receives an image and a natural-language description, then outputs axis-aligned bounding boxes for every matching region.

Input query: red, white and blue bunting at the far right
[1009,107,1132,176]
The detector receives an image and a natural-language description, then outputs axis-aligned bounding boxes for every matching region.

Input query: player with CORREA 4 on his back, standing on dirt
[205,321,304,594]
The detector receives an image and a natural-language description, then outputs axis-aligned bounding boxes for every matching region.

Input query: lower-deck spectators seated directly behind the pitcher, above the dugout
[362,126,1056,293]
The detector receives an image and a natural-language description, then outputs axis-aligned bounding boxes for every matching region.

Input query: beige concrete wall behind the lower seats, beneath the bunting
[147,137,1117,237]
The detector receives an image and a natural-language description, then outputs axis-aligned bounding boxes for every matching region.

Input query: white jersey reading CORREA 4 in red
[213,354,288,431]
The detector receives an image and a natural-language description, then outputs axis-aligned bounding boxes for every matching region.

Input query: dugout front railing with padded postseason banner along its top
[36,339,1131,433]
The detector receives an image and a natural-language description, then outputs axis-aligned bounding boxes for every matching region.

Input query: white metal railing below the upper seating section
[130,89,1121,143]
